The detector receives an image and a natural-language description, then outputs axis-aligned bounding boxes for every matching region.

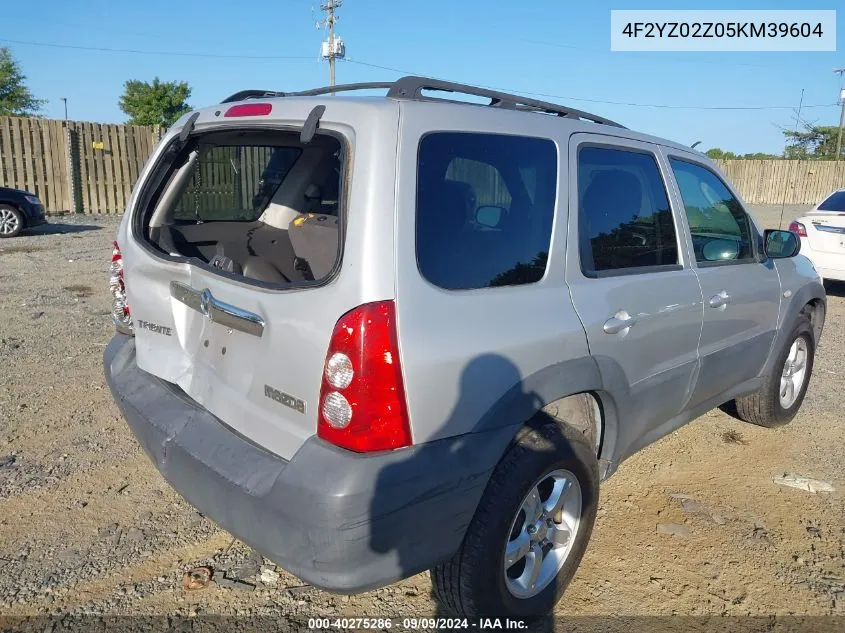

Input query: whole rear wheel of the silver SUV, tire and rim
[431,421,599,618]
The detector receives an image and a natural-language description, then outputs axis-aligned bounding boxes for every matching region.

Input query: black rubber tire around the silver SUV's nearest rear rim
[431,417,599,620]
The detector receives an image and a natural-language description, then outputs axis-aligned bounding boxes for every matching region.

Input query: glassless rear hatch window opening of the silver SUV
[144,130,345,285]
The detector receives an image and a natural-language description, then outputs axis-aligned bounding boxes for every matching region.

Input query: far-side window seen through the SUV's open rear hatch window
[173,145,301,222]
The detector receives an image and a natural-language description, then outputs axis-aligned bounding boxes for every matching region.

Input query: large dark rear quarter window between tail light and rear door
[416,132,557,290]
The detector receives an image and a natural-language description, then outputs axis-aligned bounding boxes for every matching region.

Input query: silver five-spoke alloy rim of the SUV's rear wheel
[503,469,582,599]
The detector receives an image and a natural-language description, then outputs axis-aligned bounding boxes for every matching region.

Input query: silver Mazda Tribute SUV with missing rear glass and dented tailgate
[105,77,825,617]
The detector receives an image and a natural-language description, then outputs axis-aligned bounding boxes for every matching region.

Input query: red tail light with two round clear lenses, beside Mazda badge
[317,301,411,453]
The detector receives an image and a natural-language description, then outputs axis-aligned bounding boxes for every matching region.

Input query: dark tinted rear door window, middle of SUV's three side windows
[578,146,678,276]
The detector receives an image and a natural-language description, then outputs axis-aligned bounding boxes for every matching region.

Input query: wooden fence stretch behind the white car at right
[717,160,845,204]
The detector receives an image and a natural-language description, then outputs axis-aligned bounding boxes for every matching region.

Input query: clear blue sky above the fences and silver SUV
[0,0,845,153]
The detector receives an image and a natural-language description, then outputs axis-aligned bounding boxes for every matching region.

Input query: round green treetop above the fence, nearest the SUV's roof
[119,77,191,127]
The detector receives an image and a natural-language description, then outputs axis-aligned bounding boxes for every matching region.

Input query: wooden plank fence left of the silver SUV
[0,117,161,213]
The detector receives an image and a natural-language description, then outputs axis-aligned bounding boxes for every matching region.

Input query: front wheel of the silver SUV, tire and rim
[736,314,816,428]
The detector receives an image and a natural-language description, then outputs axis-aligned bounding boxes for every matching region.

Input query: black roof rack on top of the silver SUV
[223,75,624,128]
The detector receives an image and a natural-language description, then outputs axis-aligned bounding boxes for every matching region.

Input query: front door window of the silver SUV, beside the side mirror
[669,158,754,265]
